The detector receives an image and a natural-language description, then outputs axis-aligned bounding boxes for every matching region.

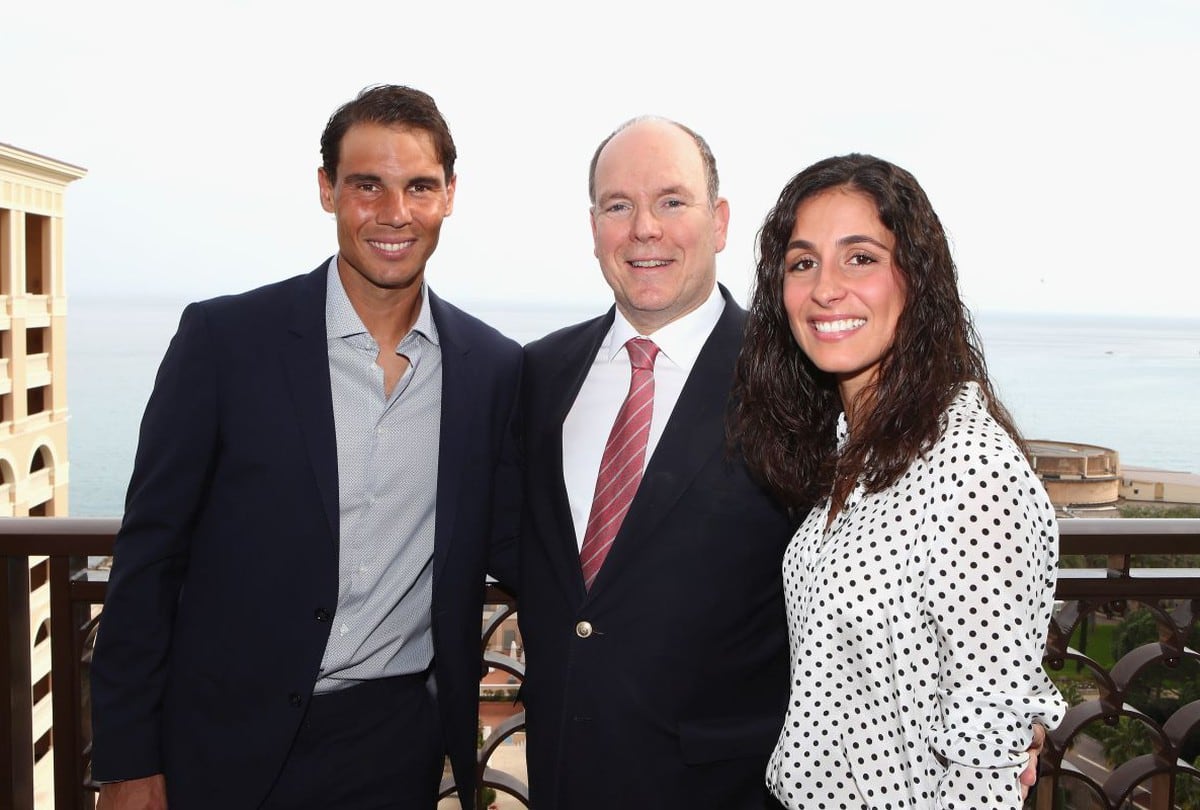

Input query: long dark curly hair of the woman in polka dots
[728,155,1021,509]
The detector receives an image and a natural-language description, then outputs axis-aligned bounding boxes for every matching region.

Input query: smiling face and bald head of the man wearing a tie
[592,120,730,335]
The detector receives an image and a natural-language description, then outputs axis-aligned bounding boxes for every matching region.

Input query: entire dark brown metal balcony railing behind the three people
[0,517,1200,810]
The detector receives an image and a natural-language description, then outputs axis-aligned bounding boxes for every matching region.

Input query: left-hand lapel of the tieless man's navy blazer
[283,263,341,546]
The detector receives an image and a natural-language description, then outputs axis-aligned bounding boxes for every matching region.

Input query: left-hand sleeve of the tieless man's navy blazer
[91,304,220,781]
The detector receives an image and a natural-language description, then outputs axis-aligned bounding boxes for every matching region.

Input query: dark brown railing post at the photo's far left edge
[0,554,34,810]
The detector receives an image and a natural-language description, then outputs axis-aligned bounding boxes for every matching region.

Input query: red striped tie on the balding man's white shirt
[580,337,659,589]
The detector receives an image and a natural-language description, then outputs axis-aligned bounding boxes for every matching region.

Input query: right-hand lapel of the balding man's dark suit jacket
[592,287,745,593]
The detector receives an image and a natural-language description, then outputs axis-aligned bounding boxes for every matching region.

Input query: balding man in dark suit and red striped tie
[520,119,792,810]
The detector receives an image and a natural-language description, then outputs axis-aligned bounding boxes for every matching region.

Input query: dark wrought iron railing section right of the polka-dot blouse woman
[1028,518,1200,810]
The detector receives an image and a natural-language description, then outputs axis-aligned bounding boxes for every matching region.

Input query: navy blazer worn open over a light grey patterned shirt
[91,263,521,810]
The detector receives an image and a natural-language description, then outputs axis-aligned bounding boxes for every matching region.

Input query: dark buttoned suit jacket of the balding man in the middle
[520,289,792,810]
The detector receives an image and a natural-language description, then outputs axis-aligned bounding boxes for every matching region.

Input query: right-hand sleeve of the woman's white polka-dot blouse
[925,422,1064,810]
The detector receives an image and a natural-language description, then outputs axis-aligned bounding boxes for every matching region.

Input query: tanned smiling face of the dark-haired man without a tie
[317,124,455,300]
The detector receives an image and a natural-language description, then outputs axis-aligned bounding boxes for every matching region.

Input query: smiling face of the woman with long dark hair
[784,188,905,415]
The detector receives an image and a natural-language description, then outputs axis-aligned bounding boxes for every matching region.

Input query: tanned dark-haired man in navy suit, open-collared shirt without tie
[92,86,521,810]
